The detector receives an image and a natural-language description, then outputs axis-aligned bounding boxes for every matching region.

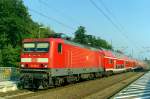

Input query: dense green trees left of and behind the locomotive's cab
[0,0,54,66]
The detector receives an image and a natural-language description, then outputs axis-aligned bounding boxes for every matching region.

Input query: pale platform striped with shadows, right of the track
[112,71,150,99]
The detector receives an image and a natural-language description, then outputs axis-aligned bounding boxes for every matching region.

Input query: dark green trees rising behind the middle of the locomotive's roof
[74,26,112,49]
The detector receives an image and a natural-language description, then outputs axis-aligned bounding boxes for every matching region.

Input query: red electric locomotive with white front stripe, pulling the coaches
[21,38,104,88]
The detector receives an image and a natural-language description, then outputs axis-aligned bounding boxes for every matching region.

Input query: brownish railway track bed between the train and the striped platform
[0,72,143,99]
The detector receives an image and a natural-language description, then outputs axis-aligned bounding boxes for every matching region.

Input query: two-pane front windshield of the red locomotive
[23,42,49,52]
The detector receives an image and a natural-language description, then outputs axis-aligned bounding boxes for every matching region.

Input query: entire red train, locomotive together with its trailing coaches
[20,37,144,89]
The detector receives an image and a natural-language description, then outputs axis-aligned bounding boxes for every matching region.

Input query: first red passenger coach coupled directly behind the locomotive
[103,50,129,73]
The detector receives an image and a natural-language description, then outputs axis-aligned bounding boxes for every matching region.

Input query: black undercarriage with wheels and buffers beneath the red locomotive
[19,69,103,89]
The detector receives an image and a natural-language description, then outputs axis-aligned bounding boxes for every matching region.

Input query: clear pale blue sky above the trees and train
[23,0,150,59]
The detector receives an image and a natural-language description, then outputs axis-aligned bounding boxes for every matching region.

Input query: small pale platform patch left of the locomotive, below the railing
[0,81,17,92]
